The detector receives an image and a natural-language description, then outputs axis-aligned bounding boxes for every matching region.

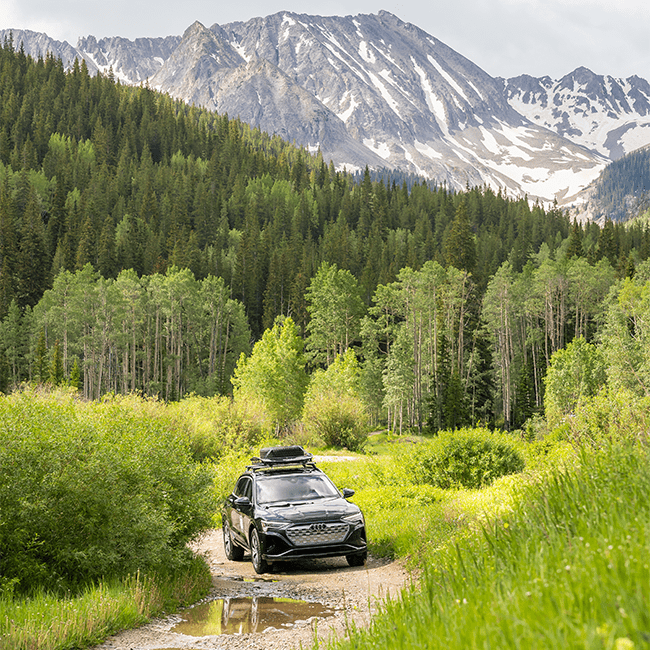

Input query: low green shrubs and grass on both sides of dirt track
[0,382,650,650]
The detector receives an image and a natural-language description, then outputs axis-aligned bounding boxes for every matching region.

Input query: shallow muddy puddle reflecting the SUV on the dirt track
[172,596,334,636]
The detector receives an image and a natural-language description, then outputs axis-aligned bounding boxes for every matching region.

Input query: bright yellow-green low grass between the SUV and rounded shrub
[319,434,560,565]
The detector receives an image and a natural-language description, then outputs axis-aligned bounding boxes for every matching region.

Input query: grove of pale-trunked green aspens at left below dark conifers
[26,265,250,399]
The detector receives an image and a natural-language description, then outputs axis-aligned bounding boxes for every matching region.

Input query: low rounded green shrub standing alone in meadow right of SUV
[411,429,525,489]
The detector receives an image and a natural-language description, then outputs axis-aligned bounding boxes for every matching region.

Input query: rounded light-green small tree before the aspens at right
[544,337,606,428]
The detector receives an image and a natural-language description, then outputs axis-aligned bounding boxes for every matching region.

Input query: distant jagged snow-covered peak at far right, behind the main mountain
[504,68,650,160]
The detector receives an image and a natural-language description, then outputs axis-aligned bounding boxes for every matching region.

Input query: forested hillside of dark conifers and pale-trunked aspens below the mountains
[0,41,650,428]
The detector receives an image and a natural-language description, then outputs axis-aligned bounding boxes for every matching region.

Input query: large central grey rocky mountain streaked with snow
[144,12,606,200]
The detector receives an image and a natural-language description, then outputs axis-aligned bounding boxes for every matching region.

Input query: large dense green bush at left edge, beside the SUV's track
[0,392,214,590]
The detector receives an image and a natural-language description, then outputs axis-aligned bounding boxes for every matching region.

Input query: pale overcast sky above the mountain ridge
[0,0,650,80]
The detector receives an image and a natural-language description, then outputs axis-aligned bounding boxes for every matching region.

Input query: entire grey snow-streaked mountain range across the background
[0,11,650,203]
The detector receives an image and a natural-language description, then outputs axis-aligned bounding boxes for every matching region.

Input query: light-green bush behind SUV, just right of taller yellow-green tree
[302,349,368,451]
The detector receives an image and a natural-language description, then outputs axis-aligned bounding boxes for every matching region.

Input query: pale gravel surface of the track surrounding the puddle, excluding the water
[94,530,412,650]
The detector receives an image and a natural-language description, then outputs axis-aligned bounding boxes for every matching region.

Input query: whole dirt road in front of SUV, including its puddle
[95,531,410,650]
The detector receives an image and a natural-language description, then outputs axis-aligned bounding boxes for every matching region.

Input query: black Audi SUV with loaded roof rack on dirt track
[221,446,368,573]
